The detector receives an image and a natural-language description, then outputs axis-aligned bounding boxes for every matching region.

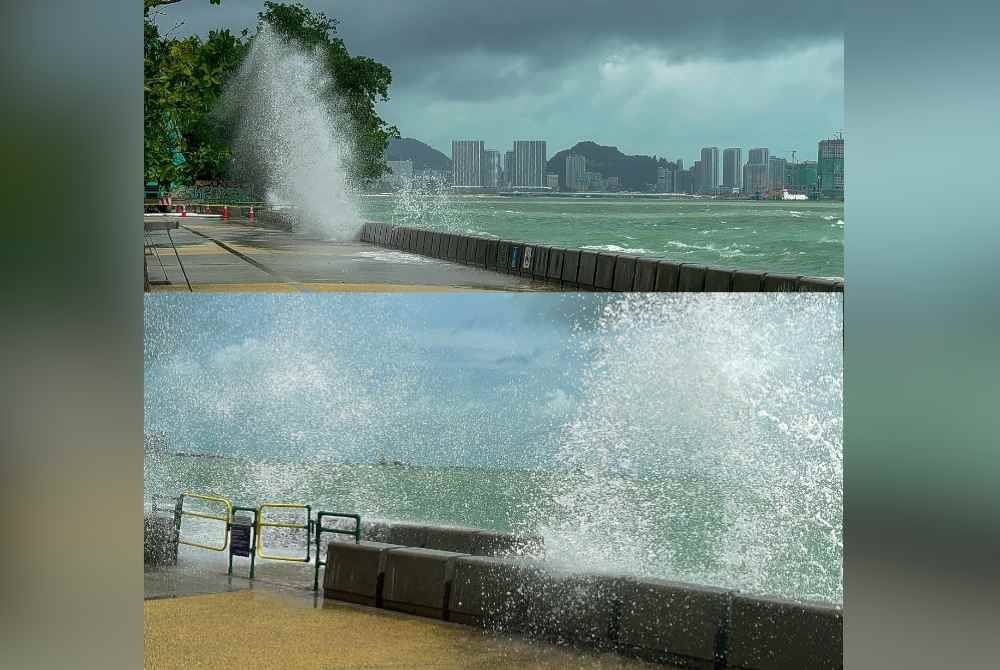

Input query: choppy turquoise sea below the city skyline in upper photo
[359,193,844,278]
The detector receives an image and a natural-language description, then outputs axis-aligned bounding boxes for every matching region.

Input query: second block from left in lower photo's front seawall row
[382,548,462,619]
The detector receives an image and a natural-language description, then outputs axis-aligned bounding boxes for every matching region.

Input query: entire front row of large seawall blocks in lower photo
[323,539,843,670]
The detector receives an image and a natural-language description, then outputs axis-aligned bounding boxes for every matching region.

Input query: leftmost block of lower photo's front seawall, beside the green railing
[323,542,402,607]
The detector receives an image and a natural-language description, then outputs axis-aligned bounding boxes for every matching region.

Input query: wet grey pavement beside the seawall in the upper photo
[145,215,553,292]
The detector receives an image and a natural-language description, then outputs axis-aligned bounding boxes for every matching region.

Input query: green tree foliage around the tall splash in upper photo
[143,0,399,188]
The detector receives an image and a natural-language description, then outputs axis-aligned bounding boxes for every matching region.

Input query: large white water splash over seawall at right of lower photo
[538,295,843,601]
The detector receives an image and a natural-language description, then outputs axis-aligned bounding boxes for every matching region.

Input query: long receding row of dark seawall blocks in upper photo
[361,222,844,293]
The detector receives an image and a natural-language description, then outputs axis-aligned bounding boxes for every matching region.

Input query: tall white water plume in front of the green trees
[220,24,362,240]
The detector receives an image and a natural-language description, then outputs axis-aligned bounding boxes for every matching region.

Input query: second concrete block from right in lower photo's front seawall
[618,579,731,664]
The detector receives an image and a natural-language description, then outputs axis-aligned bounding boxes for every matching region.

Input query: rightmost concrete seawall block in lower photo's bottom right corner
[728,595,844,670]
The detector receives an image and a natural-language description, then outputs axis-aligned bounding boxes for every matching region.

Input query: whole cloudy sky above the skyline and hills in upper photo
[157,0,844,164]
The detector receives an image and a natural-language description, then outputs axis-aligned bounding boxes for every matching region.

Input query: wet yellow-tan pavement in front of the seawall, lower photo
[143,546,665,670]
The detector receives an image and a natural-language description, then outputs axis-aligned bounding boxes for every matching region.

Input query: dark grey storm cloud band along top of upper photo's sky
[161,0,843,100]
